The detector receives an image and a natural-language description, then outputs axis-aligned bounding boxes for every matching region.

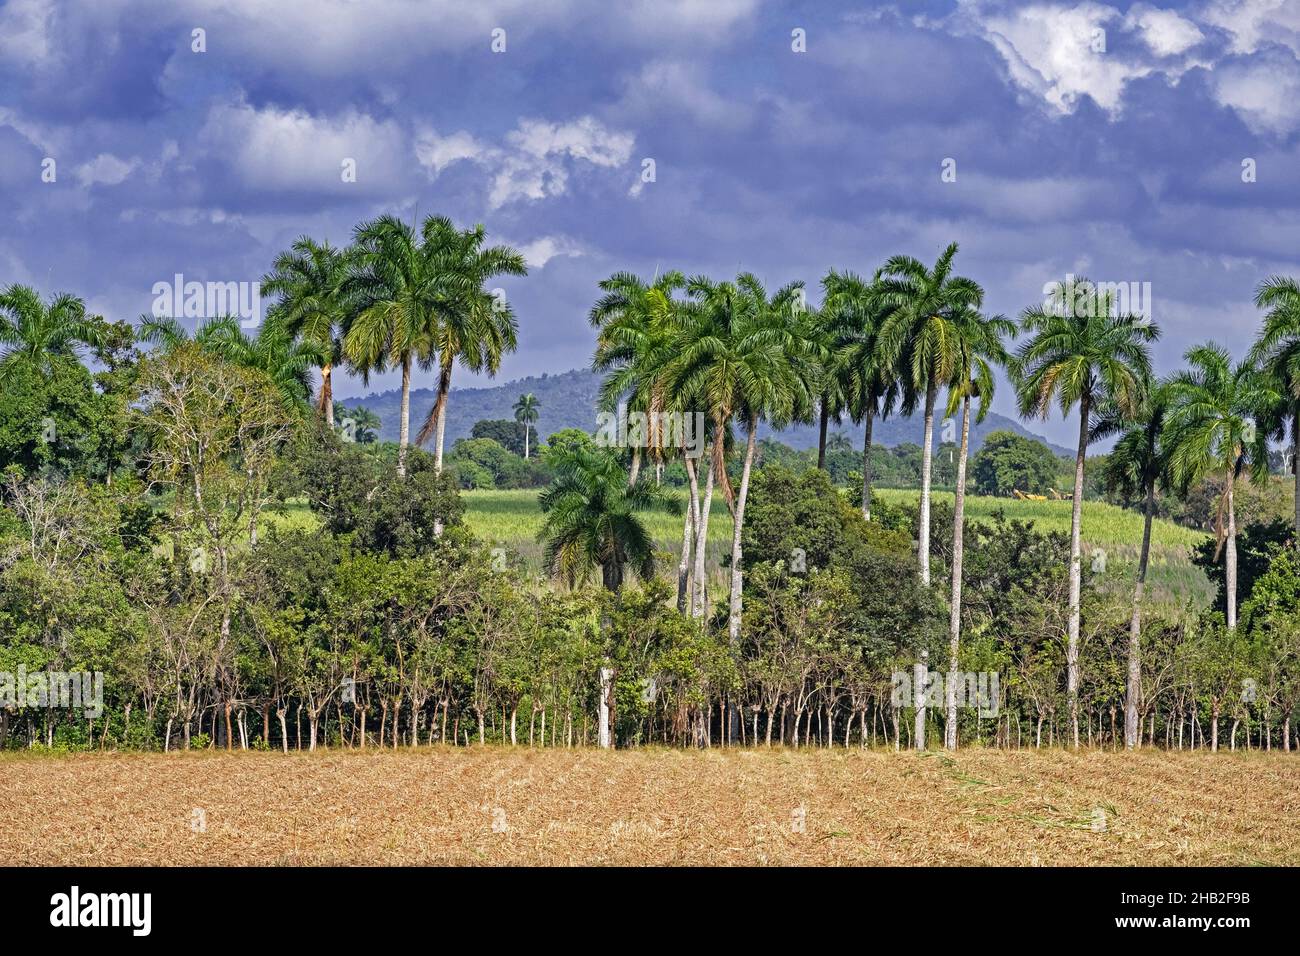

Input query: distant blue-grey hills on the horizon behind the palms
[342,368,1074,457]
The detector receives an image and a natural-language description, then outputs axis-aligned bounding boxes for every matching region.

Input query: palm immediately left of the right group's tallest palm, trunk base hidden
[822,271,898,520]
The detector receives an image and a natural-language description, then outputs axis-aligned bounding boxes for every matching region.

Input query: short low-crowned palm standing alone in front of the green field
[538,449,677,748]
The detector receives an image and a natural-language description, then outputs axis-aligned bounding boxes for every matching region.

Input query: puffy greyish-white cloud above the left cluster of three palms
[200,101,410,195]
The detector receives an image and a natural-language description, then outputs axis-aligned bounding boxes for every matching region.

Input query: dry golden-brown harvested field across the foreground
[0,748,1300,865]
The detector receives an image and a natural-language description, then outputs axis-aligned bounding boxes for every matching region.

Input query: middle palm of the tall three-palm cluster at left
[343,216,441,476]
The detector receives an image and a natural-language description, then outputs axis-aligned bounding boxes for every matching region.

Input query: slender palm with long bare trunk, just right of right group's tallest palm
[944,308,1015,750]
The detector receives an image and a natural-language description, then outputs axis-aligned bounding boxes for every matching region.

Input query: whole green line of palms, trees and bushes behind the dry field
[0,223,1300,749]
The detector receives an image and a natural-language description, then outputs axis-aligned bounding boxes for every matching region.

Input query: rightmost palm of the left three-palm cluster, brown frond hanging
[416,216,528,475]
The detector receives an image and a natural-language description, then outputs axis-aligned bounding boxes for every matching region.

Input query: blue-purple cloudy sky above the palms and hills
[0,0,1300,445]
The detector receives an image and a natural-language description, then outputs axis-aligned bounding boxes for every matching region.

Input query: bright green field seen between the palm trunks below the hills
[462,489,1212,605]
